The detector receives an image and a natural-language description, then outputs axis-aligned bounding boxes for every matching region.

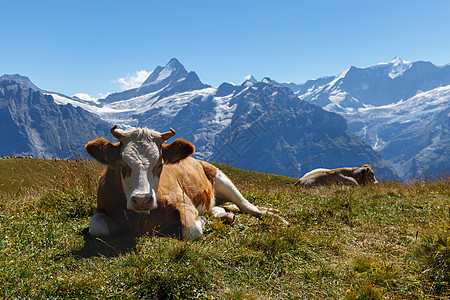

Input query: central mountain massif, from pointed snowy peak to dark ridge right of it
[42,59,396,177]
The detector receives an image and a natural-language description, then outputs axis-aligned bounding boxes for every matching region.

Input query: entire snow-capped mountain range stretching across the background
[0,59,448,178]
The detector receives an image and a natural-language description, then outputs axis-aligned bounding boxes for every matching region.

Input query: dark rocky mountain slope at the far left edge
[0,75,109,157]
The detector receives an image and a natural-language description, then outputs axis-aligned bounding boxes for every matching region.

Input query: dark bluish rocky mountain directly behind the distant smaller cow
[206,78,394,177]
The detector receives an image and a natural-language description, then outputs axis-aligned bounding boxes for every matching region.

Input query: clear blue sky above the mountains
[0,0,450,97]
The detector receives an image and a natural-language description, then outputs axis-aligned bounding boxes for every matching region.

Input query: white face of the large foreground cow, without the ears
[119,129,163,212]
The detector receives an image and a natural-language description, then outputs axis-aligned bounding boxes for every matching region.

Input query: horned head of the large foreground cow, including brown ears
[86,125,195,212]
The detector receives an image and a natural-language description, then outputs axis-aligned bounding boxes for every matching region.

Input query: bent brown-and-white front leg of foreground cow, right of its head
[178,203,205,240]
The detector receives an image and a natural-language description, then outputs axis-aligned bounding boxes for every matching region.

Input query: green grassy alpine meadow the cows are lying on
[0,159,450,299]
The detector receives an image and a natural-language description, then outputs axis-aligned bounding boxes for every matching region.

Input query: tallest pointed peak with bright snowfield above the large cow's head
[47,58,214,127]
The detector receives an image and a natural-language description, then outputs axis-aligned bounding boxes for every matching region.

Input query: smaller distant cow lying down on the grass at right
[295,165,378,188]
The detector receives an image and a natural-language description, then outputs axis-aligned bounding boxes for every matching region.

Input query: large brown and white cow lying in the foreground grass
[86,125,287,239]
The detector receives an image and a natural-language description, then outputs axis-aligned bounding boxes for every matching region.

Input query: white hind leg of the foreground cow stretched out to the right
[214,170,289,225]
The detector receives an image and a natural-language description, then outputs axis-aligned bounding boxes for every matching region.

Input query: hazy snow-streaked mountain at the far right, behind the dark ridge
[285,58,450,179]
